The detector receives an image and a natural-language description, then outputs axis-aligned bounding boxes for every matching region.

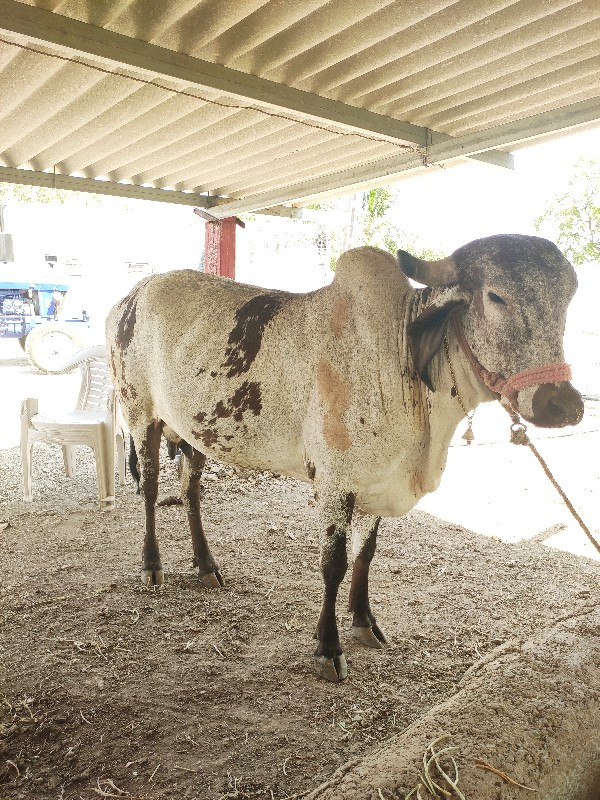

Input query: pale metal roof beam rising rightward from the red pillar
[211,97,600,217]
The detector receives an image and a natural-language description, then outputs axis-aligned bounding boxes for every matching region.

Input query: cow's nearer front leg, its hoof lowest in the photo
[315,492,355,681]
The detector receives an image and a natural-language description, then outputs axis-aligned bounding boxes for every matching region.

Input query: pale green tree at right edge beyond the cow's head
[535,158,600,264]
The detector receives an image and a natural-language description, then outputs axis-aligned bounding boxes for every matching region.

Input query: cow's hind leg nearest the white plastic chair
[133,420,164,586]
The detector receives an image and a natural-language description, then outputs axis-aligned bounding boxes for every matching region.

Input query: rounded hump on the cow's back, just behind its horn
[333,247,409,295]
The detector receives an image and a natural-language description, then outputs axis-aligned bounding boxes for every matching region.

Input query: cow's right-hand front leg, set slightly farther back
[348,514,387,648]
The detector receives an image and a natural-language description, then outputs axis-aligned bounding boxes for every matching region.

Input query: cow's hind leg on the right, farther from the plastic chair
[179,442,225,588]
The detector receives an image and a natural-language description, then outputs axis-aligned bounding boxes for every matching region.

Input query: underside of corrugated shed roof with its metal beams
[0,0,600,217]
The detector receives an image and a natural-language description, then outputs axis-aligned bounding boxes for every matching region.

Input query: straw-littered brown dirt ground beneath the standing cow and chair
[0,340,600,800]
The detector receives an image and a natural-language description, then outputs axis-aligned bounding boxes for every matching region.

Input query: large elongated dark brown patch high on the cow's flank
[221,294,284,378]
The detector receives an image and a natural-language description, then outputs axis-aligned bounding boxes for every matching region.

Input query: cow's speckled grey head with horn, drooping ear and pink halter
[398,235,583,428]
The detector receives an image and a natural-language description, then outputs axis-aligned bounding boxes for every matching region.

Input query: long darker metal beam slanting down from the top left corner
[0,0,510,166]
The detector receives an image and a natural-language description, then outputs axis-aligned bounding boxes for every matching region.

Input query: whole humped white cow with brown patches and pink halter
[106,234,583,681]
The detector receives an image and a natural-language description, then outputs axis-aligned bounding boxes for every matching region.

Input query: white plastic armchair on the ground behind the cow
[21,345,125,510]
